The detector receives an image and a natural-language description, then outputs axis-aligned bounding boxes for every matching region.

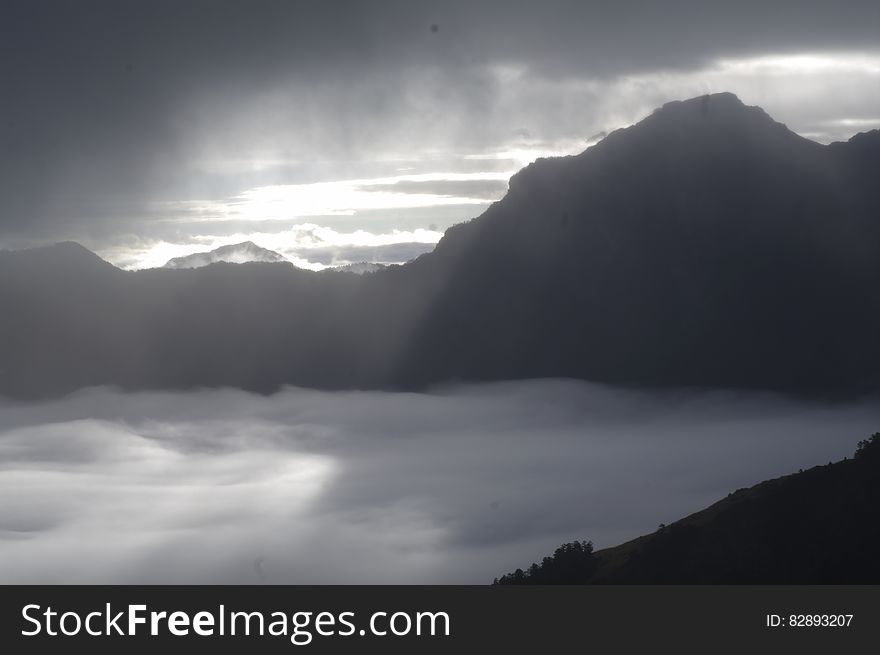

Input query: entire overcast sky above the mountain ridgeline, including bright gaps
[0,0,880,267]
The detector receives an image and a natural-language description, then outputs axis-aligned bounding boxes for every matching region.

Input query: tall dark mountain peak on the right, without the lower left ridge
[390,94,880,391]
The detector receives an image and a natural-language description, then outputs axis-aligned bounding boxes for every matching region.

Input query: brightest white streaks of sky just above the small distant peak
[100,171,515,270]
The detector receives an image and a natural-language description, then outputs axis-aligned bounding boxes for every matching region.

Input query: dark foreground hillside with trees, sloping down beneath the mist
[495,433,880,584]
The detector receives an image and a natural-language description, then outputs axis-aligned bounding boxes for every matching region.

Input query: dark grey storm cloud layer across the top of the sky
[0,0,880,243]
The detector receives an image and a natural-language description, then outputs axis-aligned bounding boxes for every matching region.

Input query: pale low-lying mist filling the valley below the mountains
[0,380,880,584]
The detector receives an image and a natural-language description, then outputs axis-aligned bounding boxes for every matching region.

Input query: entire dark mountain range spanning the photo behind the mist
[0,94,880,396]
